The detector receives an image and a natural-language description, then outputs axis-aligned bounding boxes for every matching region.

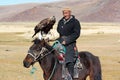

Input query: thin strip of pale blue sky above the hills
[0,0,60,5]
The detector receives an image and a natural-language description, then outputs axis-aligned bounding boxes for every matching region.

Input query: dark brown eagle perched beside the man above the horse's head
[32,16,56,38]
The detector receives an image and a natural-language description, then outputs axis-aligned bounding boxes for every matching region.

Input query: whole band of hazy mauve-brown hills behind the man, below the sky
[0,0,120,22]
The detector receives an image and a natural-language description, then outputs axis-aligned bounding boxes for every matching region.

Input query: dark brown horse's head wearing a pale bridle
[23,38,47,68]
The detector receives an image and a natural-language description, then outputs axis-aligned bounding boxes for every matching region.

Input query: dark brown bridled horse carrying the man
[23,38,102,80]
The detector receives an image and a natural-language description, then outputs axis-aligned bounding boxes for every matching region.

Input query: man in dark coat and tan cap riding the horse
[57,8,81,78]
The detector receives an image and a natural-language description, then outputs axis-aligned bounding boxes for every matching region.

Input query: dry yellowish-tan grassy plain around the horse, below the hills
[0,23,120,80]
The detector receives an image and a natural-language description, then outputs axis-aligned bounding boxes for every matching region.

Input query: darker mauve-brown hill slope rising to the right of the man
[82,0,120,22]
